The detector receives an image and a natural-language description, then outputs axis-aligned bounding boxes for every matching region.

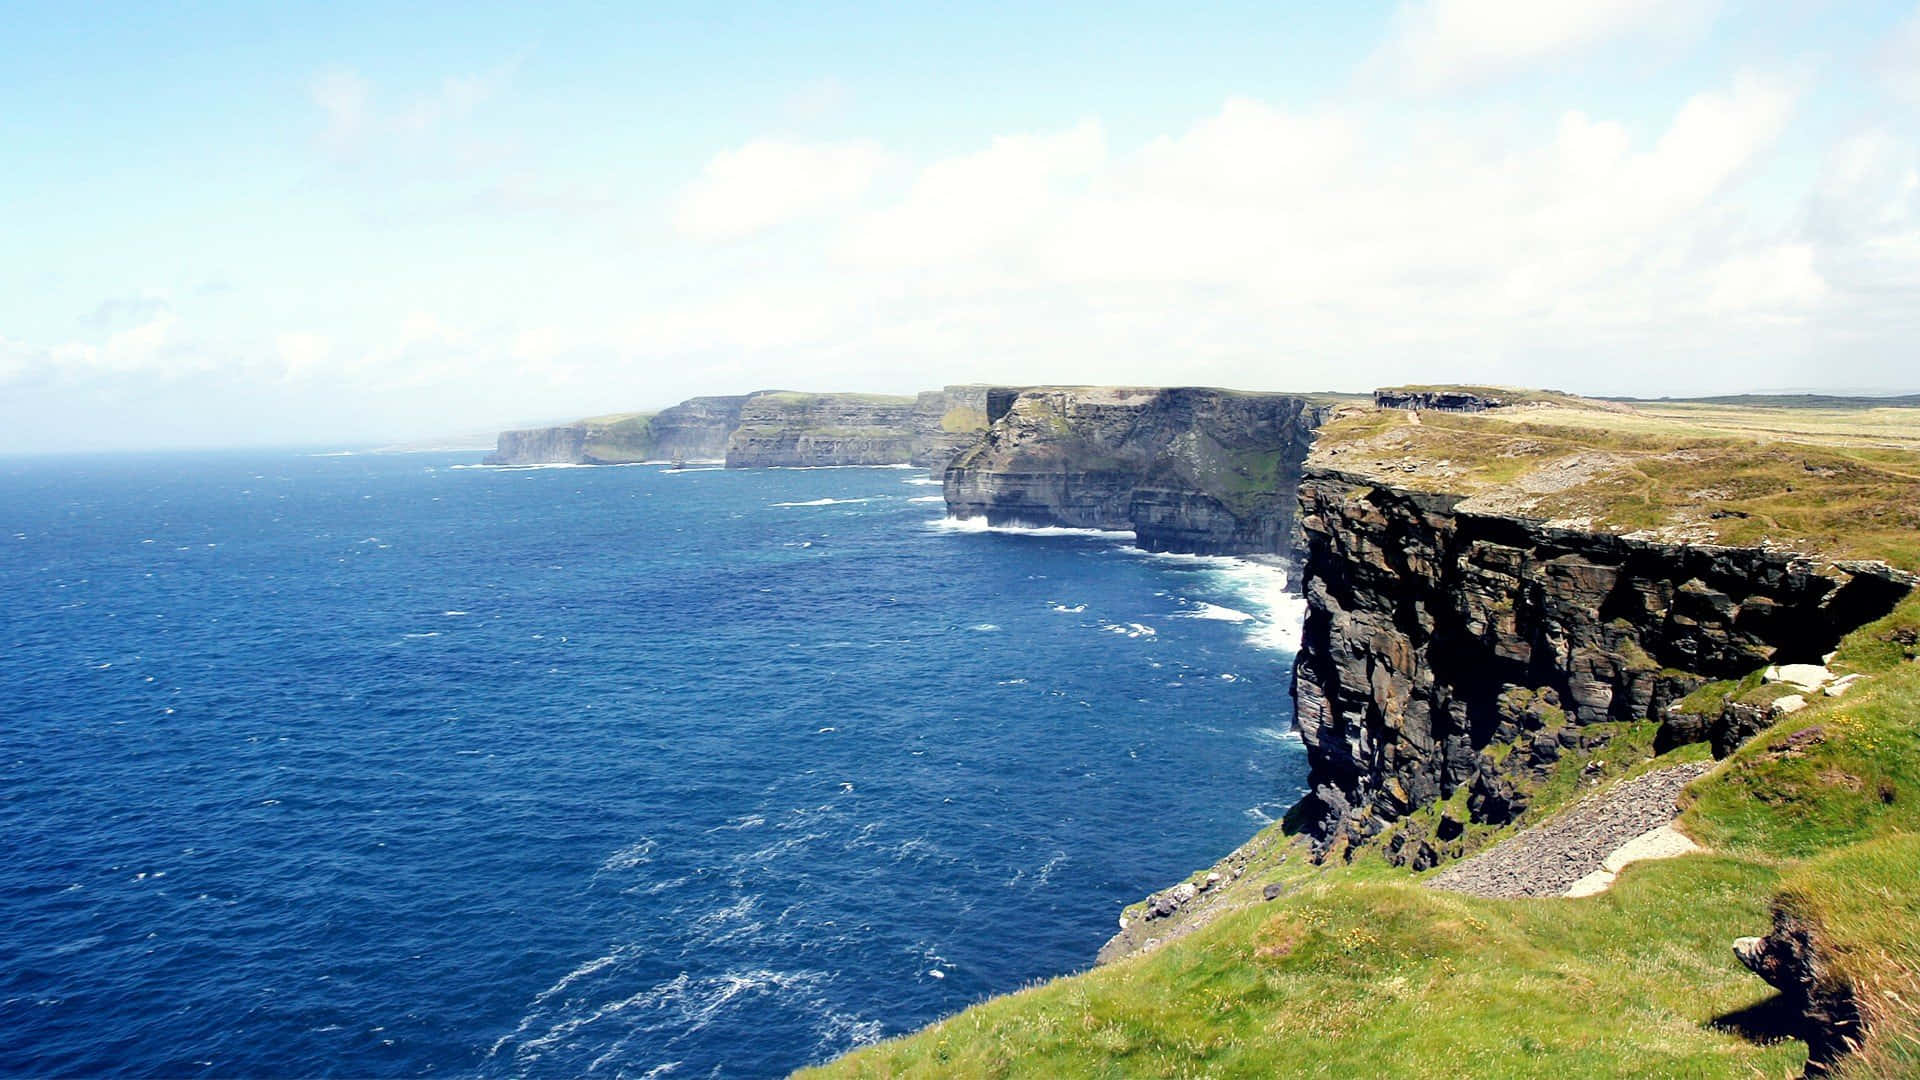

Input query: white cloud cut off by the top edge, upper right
[1373,0,1716,92]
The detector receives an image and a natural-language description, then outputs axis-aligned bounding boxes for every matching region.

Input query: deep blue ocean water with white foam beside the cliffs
[0,454,1304,1076]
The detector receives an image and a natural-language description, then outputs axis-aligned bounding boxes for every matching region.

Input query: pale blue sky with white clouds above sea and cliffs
[0,0,1920,445]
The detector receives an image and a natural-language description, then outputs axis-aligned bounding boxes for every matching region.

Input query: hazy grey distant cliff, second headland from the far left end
[726,392,914,469]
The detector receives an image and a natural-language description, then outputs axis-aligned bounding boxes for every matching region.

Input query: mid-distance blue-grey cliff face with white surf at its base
[947,388,1327,553]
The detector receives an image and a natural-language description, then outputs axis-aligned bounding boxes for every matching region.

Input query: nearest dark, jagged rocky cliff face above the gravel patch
[1294,467,1910,861]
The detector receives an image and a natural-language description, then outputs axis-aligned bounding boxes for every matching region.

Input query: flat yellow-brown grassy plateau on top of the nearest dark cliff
[1308,386,1920,571]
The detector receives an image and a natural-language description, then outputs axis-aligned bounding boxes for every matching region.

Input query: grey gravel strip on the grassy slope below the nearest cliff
[1427,761,1713,897]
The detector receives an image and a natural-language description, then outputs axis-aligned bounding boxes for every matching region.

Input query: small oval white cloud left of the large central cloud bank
[674,138,887,240]
